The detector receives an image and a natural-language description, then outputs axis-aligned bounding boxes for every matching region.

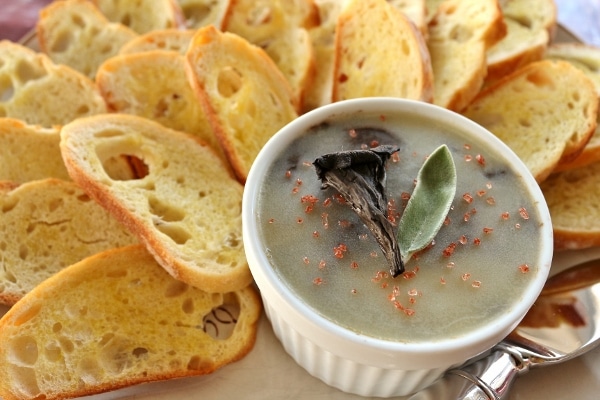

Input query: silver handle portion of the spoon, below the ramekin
[409,349,520,400]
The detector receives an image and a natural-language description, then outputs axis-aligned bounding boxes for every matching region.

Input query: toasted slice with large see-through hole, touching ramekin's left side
[60,114,252,292]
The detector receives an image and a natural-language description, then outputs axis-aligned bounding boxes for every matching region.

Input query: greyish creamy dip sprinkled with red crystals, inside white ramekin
[257,108,542,342]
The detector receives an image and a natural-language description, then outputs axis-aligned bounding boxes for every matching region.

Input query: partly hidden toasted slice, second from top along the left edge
[0,118,70,183]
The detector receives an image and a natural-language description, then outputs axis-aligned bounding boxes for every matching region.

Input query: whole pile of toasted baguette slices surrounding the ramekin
[0,0,600,399]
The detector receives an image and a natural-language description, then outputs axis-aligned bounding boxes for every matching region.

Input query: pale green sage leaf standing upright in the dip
[397,145,456,263]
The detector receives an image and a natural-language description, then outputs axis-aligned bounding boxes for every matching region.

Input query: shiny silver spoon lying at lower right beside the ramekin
[409,260,600,400]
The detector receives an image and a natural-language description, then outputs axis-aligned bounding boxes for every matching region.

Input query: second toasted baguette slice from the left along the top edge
[92,0,185,34]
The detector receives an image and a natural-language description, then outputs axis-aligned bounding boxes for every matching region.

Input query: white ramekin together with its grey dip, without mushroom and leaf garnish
[242,98,553,397]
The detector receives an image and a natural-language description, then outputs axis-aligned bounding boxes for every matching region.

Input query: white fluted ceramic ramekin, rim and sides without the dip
[242,98,553,397]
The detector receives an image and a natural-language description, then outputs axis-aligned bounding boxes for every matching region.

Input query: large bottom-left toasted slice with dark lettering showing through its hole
[0,246,261,400]
